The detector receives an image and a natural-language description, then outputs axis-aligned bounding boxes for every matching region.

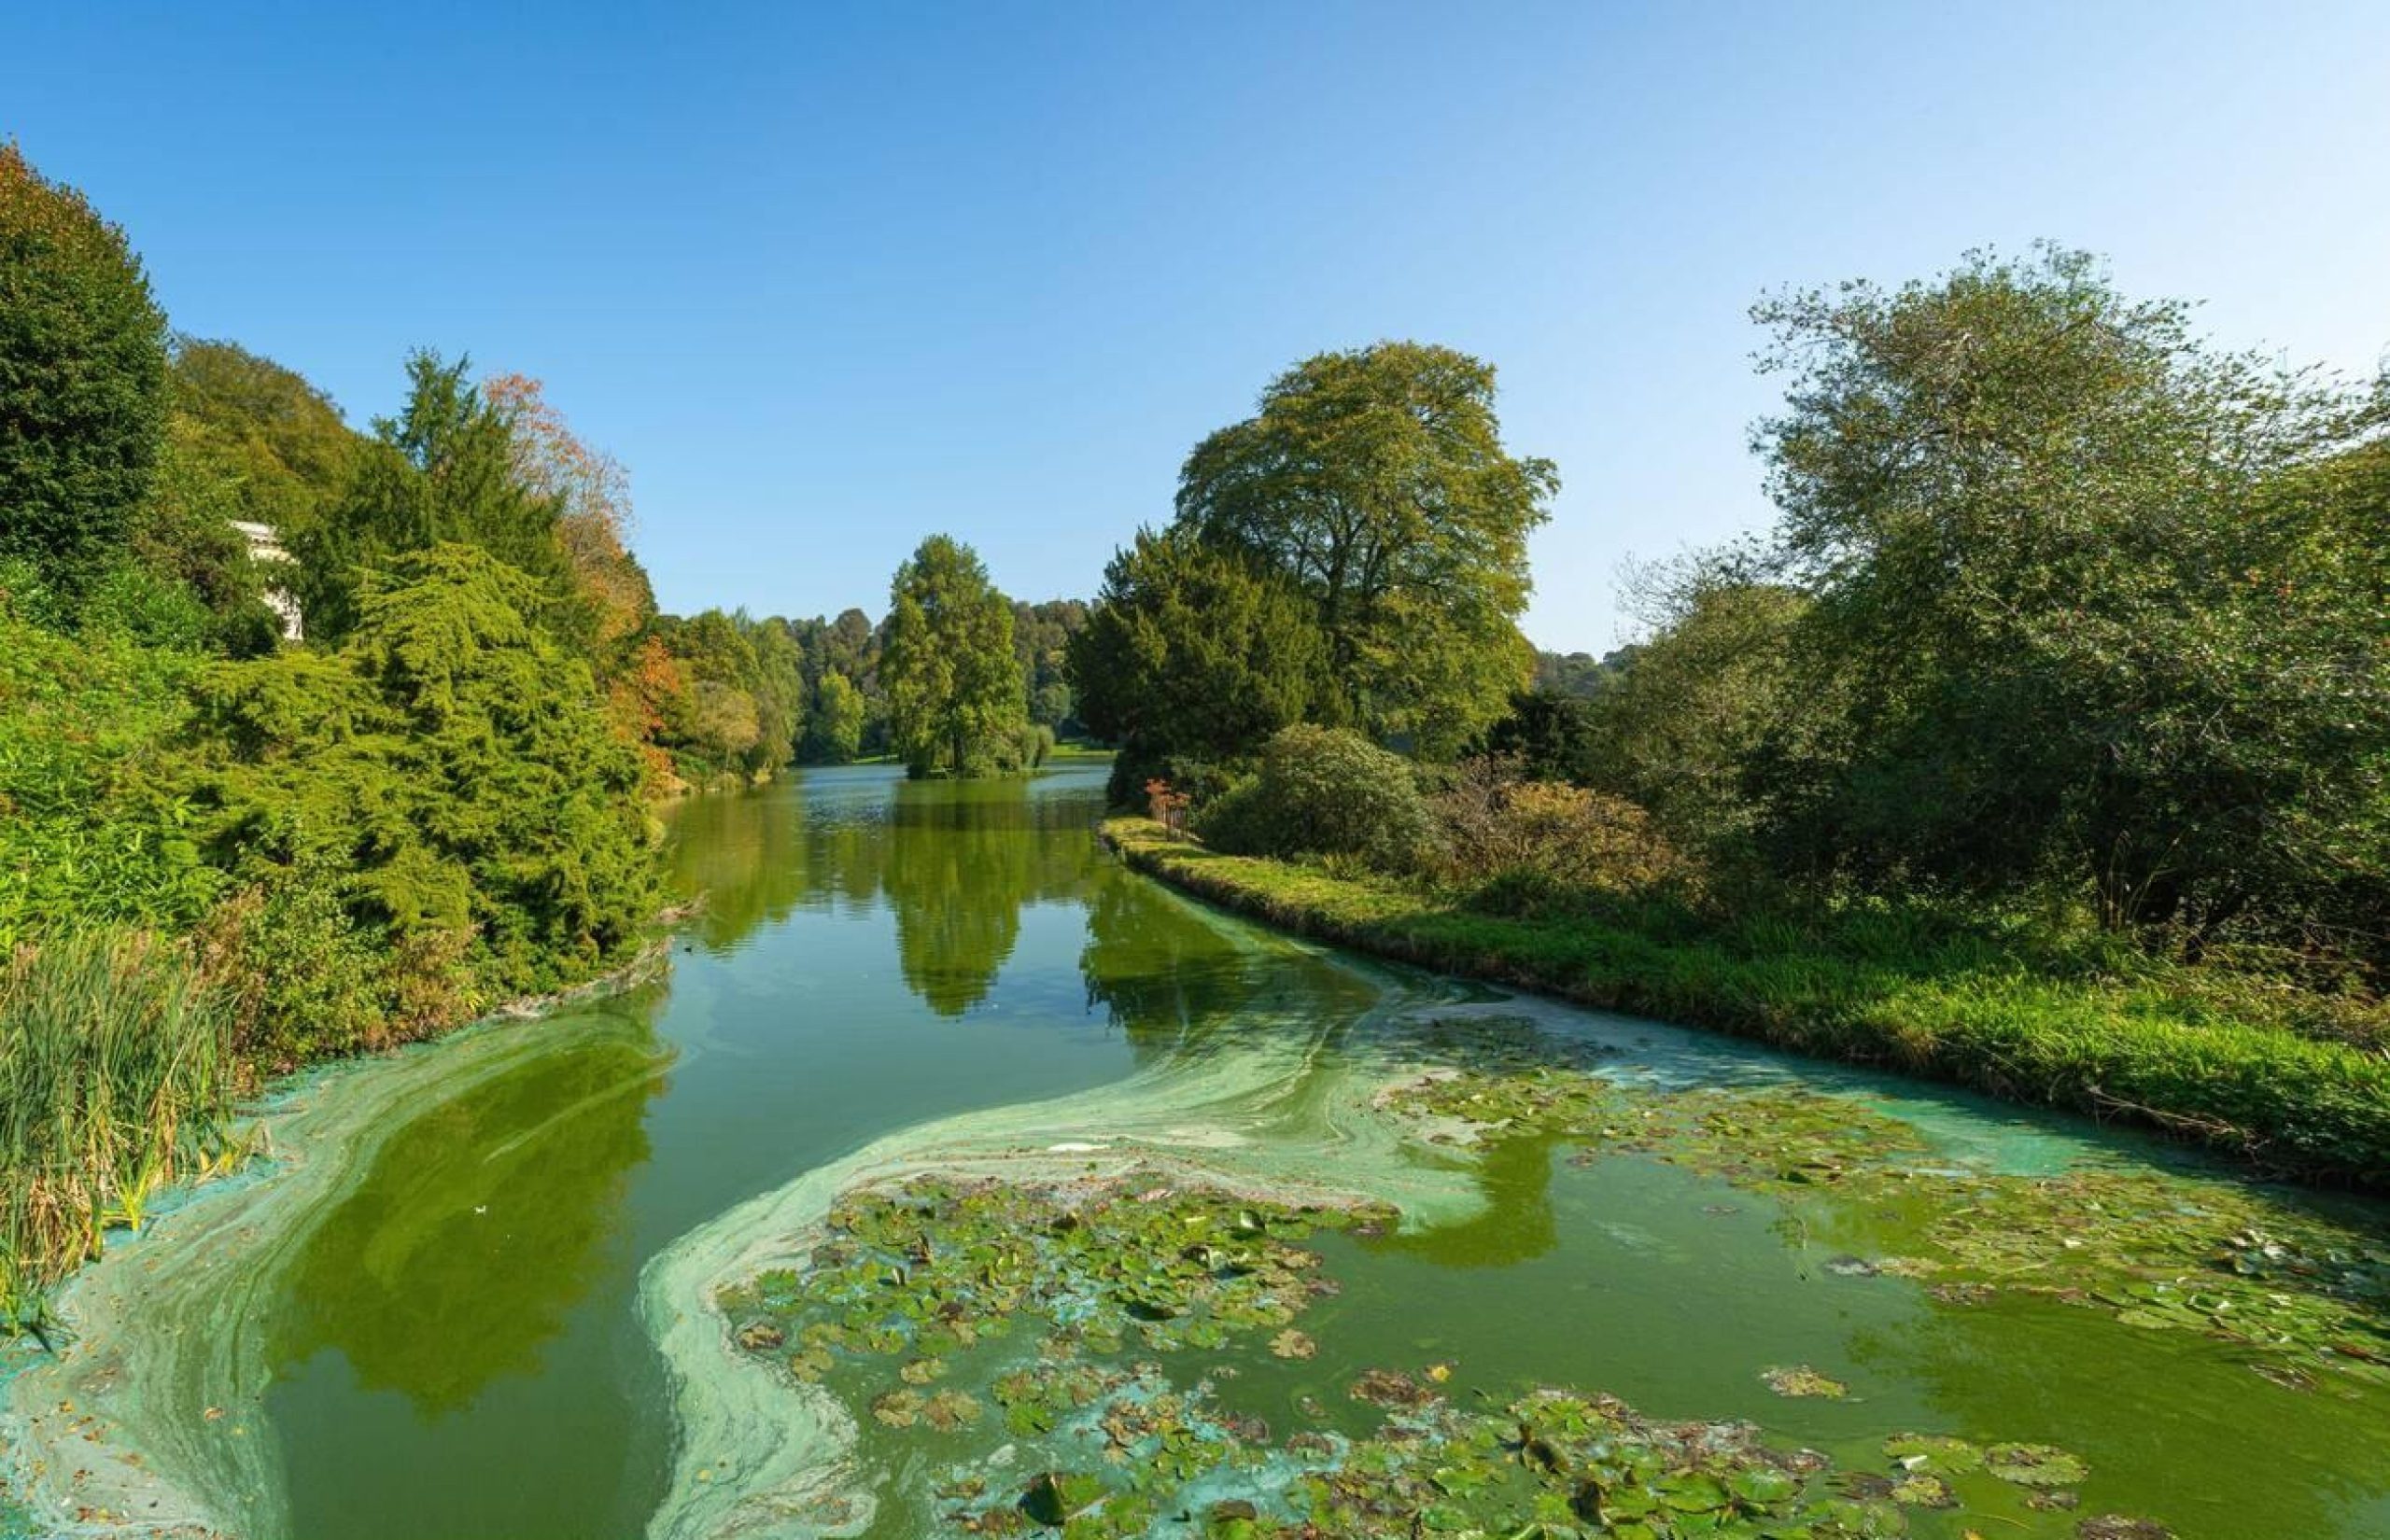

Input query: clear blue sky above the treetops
[0,0,2390,651]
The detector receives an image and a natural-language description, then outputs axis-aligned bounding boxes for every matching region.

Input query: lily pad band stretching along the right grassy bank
[1379,1065,2390,1394]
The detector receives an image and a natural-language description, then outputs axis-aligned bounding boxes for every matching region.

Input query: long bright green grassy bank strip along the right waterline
[1104,819,2390,1189]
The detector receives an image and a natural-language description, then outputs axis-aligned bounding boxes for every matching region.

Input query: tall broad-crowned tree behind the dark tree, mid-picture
[1178,342,1558,757]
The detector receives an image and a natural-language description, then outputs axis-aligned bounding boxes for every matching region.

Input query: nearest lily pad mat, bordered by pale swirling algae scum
[717,1177,2165,1540]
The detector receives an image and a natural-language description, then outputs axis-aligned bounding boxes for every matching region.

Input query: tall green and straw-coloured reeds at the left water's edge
[0,931,236,1335]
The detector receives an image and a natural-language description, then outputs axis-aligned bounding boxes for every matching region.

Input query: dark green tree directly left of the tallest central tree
[1066,530,1333,803]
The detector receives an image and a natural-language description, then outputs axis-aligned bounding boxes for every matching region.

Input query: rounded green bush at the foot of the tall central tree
[1195,726,1437,872]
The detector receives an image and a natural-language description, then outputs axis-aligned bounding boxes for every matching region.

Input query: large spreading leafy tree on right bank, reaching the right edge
[1757,248,2390,950]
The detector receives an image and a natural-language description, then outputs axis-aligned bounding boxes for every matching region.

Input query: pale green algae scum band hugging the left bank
[0,926,696,1540]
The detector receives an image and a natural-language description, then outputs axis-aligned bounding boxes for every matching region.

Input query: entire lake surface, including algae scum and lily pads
[0,766,2390,1540]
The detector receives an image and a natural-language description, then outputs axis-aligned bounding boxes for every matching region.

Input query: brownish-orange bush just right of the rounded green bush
[1437,759,1692,903]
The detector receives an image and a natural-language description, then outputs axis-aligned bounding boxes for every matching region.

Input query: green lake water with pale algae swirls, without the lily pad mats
[0,766,2390,1540]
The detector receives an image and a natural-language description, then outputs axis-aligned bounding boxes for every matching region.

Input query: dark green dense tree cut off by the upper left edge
[0,143,165,592]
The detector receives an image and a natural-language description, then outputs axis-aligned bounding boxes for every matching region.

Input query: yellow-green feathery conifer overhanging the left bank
[198,544,653,998]
